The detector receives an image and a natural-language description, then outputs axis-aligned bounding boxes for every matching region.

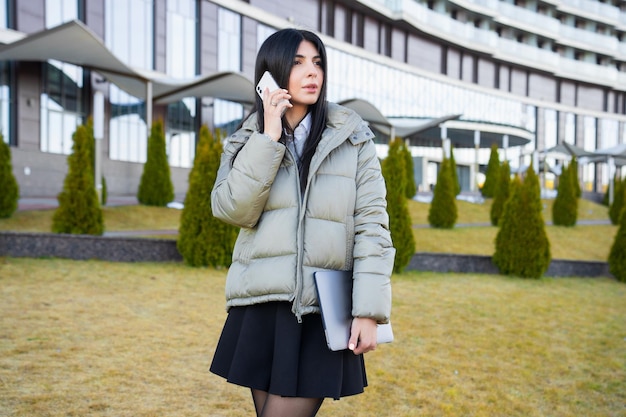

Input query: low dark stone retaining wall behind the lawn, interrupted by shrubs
[0,232,611,277]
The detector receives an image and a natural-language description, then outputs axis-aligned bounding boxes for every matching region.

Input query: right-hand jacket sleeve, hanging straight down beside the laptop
[352,128,395,323]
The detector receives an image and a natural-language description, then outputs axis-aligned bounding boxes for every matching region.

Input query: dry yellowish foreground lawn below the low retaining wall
[0,258,626,417]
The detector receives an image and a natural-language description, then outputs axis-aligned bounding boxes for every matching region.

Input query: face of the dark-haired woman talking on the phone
[287,41,324,107]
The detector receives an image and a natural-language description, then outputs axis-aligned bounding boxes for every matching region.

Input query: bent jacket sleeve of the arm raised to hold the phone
[211,132,285,228]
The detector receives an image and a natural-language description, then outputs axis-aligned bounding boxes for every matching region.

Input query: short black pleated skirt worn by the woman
[210,302,367,399]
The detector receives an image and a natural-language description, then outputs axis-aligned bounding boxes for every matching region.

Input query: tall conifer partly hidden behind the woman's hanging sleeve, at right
[382,139,415,273]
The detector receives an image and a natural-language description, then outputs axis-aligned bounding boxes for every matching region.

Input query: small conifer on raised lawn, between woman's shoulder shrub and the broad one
[428,158,458,229]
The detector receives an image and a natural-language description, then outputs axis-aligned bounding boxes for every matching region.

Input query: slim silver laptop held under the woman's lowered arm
[313,271,393,350]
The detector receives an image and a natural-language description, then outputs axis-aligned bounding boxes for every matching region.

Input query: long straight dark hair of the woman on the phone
[251,29,328,190]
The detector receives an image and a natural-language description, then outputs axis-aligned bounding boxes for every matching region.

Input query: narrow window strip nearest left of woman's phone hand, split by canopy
[213,8,244,134]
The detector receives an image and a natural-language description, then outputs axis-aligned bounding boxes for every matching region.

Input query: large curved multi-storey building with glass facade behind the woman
[0,0,626,194]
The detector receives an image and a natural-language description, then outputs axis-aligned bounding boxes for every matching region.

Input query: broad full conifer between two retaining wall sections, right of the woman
[492,166,550,278]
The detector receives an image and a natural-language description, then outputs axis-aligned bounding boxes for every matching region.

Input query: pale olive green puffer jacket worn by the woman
[211,103,395,323]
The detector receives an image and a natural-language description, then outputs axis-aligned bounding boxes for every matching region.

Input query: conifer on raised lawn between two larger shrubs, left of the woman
[137,120,174,207]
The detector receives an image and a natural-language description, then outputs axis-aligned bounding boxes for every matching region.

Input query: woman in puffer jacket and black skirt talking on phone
[211,29,395,417]
